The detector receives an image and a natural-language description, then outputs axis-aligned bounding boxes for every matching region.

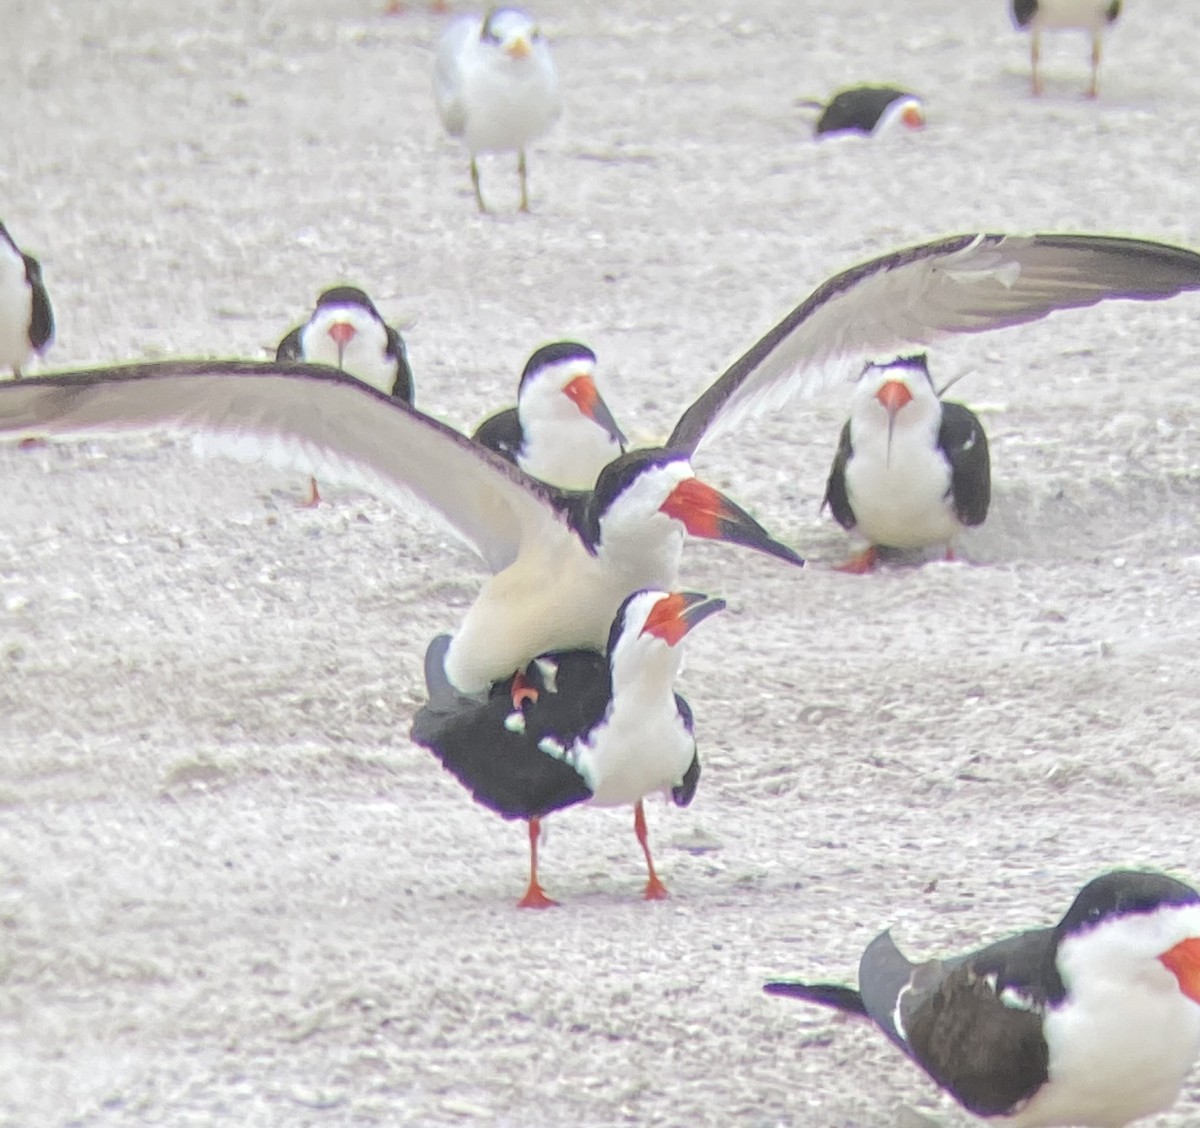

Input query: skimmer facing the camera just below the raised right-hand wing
[823,355,991,572]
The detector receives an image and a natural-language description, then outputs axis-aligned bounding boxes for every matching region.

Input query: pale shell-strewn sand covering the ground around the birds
[0,0,1200,1128]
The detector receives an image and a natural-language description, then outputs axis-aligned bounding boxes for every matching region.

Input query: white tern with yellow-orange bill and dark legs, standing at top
[433,7,562,212]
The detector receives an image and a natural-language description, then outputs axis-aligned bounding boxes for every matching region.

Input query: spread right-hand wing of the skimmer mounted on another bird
[667,235,1200,454]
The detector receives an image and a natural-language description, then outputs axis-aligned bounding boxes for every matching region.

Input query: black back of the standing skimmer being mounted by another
[412,650,612,818]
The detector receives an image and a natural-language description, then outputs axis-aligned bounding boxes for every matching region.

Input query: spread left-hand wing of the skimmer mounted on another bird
[0,360,575,571]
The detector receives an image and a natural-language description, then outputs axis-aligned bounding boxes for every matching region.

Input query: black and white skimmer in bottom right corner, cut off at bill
[766,870,1200,1128]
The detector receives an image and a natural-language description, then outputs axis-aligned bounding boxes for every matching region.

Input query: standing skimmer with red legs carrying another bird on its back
[413,592,725,908]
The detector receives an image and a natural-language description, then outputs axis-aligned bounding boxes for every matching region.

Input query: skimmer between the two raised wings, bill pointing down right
[473,341,625,490]
